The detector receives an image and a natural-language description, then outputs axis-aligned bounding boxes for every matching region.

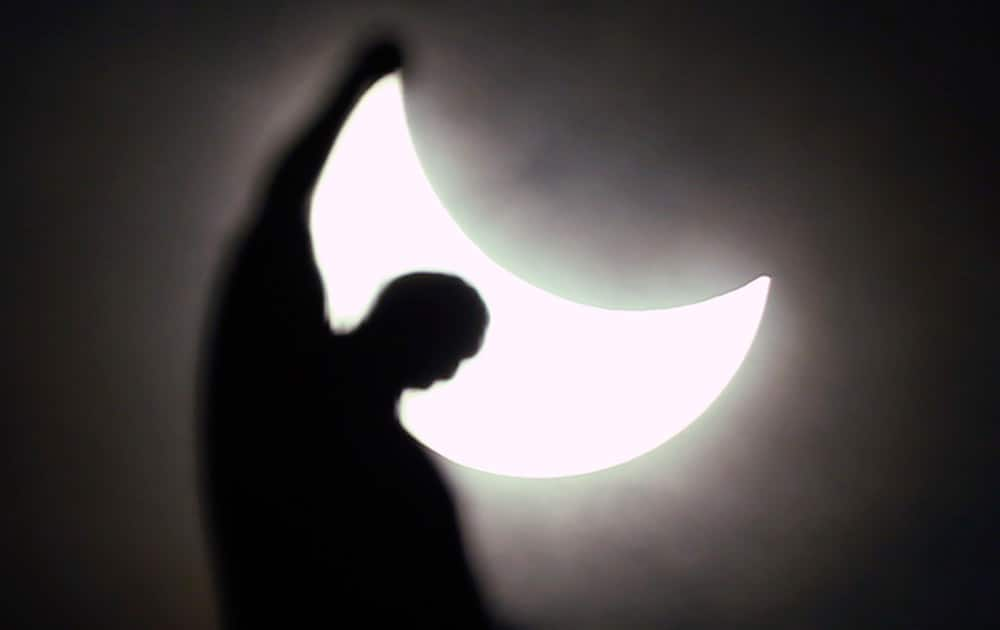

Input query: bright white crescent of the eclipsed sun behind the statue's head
[311,72,770,477]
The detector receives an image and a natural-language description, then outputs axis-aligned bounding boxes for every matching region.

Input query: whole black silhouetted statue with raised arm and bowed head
[202,45,489,630]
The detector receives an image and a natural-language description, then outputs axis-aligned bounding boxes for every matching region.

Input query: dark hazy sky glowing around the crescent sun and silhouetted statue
[0,2,1000,629]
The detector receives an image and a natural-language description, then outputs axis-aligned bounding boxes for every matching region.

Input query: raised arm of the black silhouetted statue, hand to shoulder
[216,43,402,362]
